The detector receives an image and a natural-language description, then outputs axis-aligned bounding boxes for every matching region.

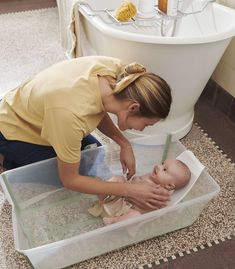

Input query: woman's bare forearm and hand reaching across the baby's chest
[57,158,170,209]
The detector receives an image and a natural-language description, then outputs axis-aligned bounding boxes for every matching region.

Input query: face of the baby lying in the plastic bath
[150,159,180,186]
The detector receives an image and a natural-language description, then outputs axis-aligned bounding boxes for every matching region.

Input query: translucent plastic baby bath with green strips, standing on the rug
[1,137,219,269]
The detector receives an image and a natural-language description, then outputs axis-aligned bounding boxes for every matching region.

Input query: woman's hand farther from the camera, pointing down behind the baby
[120,143,135,179]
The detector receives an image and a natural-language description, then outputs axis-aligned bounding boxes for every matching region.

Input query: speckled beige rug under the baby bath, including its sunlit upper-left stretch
[0,8,235,269]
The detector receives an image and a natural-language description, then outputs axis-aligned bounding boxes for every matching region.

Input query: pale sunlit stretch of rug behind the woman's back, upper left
[0,8,65,98]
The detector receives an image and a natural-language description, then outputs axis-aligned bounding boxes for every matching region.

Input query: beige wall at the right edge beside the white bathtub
[212,0,235,97]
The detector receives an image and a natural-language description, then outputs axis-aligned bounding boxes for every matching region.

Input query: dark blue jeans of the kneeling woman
[0,133,101,170]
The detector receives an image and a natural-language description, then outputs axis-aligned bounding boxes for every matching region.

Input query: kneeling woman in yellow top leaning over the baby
[0,56,171,209]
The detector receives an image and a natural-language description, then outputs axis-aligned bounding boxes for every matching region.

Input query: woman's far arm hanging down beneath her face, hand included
[97,113,135,179]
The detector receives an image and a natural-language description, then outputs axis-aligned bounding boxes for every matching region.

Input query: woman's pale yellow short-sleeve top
[0,56,124,163]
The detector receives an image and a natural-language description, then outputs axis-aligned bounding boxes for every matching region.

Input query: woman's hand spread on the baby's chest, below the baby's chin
[128,181,170,210]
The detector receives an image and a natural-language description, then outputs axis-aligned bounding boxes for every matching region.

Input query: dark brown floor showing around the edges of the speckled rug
[0,0,235,269]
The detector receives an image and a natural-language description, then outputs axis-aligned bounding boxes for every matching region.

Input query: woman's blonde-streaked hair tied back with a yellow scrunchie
[113,63,172,119]
